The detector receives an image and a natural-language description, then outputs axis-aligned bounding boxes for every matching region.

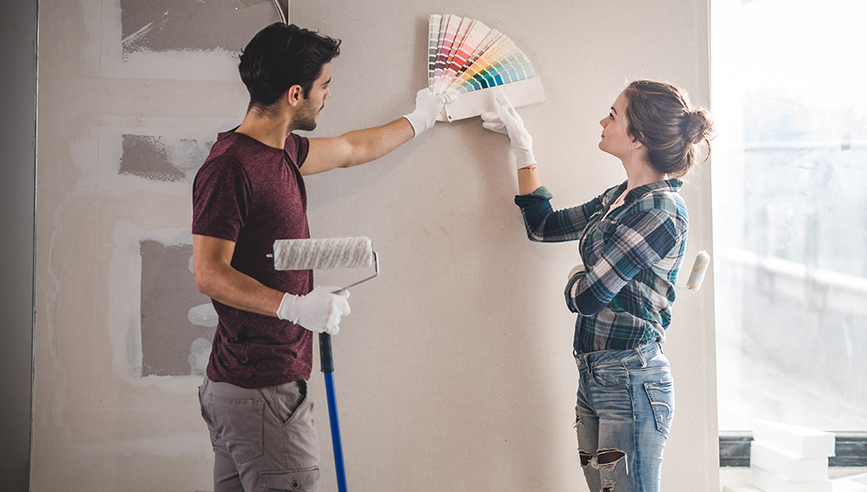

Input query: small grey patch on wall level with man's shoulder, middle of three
[118,134,213,181]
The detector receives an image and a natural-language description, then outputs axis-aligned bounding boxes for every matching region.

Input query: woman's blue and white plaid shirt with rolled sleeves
[515,179,689,353]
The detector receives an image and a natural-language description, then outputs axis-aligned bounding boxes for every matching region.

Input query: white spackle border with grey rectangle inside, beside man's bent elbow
[109,221,217,384]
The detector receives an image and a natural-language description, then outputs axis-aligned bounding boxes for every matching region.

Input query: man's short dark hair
[238,22,340,114]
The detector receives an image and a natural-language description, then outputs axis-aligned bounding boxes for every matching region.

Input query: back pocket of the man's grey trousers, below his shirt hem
[209,396,265,464]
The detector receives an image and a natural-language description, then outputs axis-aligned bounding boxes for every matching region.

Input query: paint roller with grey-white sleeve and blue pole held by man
[268,237,379,492]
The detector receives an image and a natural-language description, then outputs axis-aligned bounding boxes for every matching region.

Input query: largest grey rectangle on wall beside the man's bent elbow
[140,240,214,376]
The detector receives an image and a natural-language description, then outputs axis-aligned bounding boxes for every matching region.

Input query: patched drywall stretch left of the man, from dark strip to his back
[31,0,278,491]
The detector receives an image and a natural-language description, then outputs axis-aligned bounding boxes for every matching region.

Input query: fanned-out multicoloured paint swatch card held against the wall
[428,14,545,121]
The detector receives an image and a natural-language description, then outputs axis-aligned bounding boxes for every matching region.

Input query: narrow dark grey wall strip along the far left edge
[0,0,36,492]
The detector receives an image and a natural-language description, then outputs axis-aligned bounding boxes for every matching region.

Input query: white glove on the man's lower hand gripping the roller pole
[277,285,349,335]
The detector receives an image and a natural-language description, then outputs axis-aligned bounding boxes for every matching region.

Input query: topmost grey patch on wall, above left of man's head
[120,0,278,56]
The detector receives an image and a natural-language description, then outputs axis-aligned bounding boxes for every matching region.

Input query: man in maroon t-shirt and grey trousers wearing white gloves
[192,23,446,492]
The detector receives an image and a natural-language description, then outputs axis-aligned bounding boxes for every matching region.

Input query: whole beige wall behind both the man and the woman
[32,0,718,491]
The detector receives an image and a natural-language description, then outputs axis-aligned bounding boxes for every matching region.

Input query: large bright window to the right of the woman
[711,0,867,442]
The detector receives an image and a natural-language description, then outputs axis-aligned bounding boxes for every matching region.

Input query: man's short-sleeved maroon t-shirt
[192,132,313,388]
